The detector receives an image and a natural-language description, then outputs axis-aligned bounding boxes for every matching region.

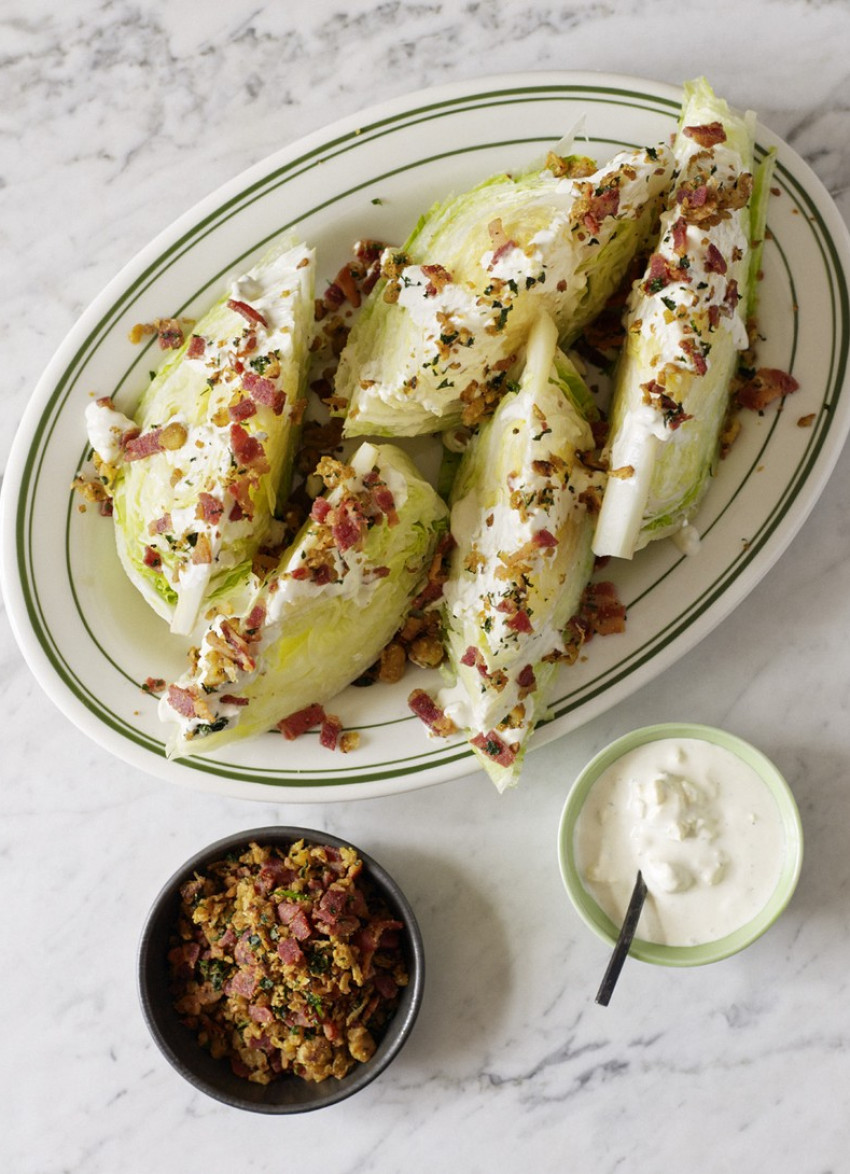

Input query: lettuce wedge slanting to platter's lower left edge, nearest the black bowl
[160,444,448,756]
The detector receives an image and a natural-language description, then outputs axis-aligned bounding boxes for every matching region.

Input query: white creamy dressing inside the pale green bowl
[574,738,784,946]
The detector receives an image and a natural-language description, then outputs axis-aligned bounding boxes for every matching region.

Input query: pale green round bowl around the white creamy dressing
[558,722,803,966]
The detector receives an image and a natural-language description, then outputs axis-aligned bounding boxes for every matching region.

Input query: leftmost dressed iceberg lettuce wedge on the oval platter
[87,239,315,634]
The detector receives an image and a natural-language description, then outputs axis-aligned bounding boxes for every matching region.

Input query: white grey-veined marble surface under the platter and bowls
[0,0,850,1174]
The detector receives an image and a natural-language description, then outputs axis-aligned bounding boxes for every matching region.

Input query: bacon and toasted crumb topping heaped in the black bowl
[168,839,410,1085]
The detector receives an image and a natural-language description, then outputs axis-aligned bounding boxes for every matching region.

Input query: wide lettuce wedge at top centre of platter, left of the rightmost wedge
[336,147,670,436]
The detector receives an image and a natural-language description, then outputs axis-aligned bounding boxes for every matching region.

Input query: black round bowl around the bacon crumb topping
[139,826,425,1113]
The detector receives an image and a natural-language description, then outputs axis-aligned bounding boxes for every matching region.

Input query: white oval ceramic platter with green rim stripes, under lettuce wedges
[2,73,850,802]
